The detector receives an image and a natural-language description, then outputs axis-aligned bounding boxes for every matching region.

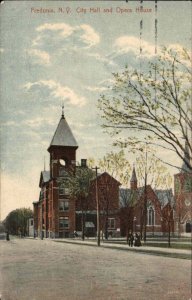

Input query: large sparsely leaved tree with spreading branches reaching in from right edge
[98,48,192,171]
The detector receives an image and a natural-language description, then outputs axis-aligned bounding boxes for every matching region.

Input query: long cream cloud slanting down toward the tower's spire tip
[23,80,86,106]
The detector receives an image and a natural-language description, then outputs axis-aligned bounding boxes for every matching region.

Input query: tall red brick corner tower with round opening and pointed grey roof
[48,106,78,237]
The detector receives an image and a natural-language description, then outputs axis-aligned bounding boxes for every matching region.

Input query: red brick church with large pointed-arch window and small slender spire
[120,168,174,236]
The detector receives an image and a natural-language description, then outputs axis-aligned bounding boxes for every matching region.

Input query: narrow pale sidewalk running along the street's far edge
[52,239,192,259]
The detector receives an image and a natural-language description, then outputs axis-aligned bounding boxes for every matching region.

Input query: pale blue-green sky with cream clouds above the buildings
[0,1,192,220]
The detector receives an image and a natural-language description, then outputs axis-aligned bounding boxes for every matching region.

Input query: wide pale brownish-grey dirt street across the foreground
[0,239,191,300]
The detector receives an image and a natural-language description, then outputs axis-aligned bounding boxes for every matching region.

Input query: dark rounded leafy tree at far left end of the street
[4,208,33,236]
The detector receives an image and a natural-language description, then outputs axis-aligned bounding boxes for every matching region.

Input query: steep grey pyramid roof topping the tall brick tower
[48,110,78,150]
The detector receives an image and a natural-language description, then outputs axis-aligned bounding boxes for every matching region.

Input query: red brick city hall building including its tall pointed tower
[33,112,120,238]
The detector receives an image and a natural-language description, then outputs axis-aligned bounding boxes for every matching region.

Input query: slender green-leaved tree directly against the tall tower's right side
[68,167,94,240]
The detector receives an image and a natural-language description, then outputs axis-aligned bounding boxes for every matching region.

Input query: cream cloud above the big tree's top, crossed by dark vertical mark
[114,35,158,58]
